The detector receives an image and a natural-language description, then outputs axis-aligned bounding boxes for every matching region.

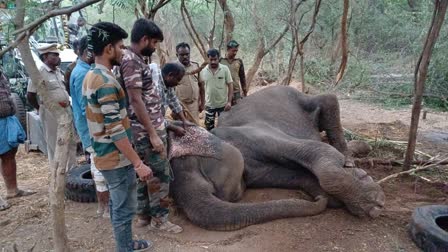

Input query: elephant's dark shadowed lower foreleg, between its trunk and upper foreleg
[246,163,343,208]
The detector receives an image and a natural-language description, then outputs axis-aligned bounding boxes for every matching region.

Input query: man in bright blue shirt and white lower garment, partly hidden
[70,36,109,218]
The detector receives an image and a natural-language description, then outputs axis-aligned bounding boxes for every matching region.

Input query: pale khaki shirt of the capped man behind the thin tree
[27,64,70,105]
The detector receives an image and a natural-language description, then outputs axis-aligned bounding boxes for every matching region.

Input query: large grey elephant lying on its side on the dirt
[169,86,385,231]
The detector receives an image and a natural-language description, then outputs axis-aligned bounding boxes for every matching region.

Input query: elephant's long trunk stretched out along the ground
[172,167,327,231]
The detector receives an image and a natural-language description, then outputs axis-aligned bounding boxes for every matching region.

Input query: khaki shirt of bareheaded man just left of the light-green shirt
[176,62,199,104]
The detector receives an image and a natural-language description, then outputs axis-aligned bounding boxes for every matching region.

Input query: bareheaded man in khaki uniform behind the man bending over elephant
[176,42,205,122]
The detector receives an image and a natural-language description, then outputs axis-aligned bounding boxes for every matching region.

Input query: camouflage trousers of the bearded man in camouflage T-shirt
[135,130,172,218]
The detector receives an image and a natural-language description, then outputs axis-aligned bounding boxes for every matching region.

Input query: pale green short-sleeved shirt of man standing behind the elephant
[199,64,233,108]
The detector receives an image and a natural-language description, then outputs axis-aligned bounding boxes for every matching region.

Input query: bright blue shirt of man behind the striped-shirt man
[70,59,91,150]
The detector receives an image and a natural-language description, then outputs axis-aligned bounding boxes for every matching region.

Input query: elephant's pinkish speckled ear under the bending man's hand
[168,126,222,160]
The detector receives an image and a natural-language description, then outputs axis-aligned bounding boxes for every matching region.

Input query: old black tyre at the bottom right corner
[410,205,448,252]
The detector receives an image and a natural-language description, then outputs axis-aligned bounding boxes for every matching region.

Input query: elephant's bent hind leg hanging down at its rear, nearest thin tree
[312,94,355,167]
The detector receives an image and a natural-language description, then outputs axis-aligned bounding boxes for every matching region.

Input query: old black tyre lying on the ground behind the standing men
[65,164,97,203]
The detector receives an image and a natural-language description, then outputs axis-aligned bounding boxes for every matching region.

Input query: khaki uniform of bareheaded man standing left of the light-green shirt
[176,62,199,122]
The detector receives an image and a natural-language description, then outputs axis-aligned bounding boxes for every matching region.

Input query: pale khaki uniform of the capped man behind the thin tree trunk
[27,64,76,168]
